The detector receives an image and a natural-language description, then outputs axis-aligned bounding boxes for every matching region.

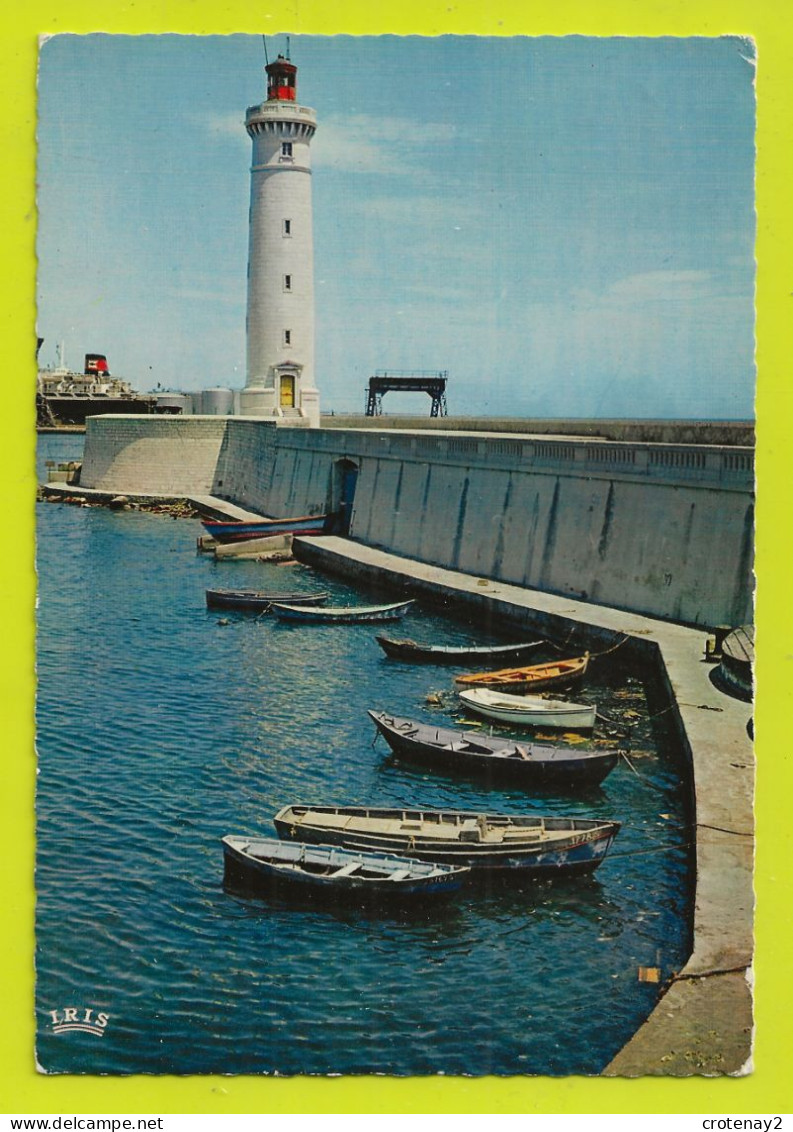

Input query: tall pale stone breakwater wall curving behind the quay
[81,417,753,626]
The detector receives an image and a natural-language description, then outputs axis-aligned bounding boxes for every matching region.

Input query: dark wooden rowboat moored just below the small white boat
[369,711,619,789]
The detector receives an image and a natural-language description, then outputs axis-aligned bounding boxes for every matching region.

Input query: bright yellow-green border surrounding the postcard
[0,0,793,1115]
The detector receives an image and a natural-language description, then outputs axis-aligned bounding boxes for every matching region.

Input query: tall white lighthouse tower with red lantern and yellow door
[240,55,319,428]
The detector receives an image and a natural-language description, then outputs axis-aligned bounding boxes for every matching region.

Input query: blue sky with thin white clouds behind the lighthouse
[37,35,755,419]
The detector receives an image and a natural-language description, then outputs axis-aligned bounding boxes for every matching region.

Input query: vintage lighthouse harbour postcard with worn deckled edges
[3,2,787,1112]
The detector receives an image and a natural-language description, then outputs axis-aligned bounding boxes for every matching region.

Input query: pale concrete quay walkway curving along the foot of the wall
[293,535,755,1077]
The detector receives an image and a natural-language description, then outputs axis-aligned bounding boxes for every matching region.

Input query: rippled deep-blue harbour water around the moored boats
[36,436,692,1075]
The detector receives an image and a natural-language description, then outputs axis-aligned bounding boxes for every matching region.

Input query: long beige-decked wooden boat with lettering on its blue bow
[274,805,620,877]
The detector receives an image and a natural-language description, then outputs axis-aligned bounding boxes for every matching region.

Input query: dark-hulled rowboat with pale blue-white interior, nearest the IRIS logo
[222,834,469,901]
